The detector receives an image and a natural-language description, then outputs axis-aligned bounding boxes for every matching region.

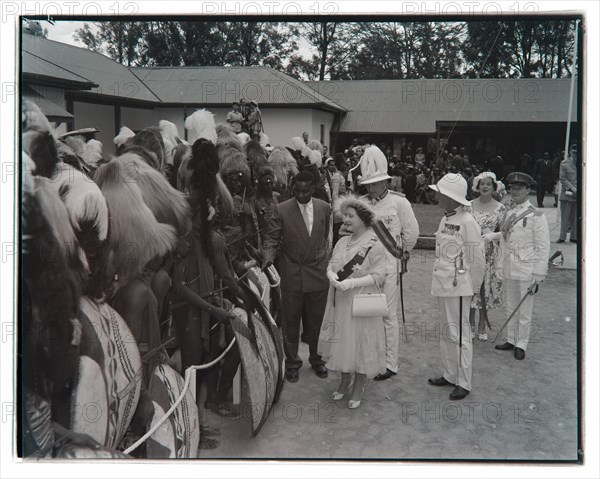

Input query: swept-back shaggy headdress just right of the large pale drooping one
[113,153,191,235]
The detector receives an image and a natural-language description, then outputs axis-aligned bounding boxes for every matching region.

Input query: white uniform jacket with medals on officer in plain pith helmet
[431,206,485,297]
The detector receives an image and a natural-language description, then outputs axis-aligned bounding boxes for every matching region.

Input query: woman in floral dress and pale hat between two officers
[469,171,505,341]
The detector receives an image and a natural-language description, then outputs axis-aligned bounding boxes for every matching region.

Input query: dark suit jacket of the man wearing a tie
[264,198,331,293]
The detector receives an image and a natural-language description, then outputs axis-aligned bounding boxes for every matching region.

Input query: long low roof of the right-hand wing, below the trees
[306,78,577,133]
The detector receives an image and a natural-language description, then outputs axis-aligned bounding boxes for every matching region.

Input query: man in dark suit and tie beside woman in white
[264,171,331,382]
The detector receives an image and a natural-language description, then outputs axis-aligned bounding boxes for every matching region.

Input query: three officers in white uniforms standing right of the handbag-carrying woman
[328,146,550,400]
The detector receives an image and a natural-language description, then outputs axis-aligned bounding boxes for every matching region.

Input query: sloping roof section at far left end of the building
[22,35,159,102]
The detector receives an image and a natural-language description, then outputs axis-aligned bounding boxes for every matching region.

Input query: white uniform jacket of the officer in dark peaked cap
[500,201,550,280]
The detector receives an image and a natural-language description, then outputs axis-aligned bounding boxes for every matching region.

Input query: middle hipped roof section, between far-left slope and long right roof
[131,66,345,111]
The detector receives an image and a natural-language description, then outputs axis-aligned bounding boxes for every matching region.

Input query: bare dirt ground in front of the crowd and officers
[198,198,579,461]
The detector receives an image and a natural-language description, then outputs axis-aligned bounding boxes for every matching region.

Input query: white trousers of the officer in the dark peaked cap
[502,278,533,351]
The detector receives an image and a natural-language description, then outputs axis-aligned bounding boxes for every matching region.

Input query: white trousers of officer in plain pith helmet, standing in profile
[439,296,473,391]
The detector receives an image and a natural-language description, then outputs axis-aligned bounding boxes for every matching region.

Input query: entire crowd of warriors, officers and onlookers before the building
[23,101,577,462]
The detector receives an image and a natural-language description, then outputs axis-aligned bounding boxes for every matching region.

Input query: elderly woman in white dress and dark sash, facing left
[318,198,386,409]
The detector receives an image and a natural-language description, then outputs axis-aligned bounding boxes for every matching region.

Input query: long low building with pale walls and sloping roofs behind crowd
[21,34,578,162]
